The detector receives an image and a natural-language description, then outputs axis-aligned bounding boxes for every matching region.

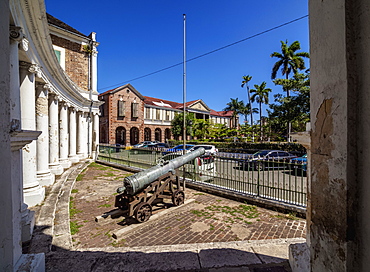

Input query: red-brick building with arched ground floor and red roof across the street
[99,84,238,145]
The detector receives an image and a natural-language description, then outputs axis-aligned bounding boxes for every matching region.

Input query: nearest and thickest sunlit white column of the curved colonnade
[20,62,45,206]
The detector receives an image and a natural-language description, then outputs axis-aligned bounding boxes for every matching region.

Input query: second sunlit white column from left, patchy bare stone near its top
[36,84,55,186]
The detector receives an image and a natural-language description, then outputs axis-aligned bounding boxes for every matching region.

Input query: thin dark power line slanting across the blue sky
[99,15,308,90]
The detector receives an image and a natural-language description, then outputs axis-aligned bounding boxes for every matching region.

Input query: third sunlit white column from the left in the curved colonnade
[49,94,63,175]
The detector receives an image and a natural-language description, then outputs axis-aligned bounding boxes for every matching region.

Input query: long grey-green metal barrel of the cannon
[117,147,205,195]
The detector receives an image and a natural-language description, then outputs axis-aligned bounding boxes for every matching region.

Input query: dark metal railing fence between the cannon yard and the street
[98,145,307,209]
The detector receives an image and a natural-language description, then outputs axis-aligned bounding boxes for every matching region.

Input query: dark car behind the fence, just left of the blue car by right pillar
[239,150,297,170]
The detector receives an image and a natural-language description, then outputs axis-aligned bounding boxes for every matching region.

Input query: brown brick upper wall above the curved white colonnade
[50,35,89,91]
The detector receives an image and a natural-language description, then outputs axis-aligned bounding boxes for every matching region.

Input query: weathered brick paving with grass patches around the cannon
[71,163,306,249]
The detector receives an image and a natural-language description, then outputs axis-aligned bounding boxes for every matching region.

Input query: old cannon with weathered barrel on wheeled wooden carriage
[115,148,205,223]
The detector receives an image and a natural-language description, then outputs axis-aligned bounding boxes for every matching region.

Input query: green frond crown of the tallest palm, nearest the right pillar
[271,41,310,97]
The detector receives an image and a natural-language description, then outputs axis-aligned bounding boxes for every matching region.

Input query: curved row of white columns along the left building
[10,27,99,223]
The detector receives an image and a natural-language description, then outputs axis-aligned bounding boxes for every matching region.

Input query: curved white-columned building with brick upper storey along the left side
[0,0,100,271]
